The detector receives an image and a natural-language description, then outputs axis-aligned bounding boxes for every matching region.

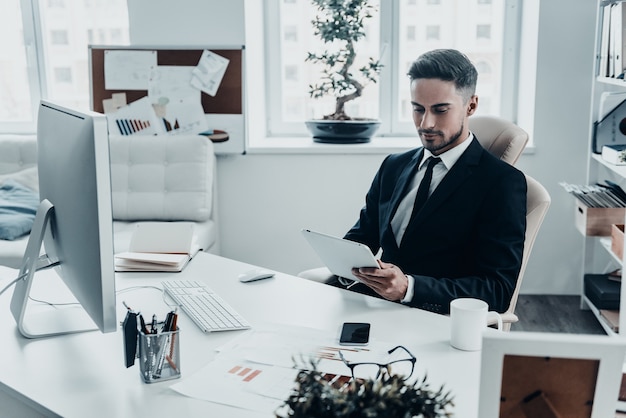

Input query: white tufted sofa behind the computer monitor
[0,135,219,268]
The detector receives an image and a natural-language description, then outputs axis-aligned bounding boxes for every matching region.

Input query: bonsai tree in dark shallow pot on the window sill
[305,0,382,143]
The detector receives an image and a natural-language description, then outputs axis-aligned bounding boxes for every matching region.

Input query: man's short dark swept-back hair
[408,49,478,102]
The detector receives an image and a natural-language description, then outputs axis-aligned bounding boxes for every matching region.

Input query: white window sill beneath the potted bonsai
[246,136,421,154]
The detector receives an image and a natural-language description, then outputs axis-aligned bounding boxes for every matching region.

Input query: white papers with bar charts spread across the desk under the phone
[171,325,391,413]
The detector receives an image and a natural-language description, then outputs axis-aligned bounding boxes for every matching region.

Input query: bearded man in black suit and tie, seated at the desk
[331,50,526,313]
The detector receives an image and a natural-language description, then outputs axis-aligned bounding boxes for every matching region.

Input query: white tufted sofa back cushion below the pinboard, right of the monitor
[110,135,215,221]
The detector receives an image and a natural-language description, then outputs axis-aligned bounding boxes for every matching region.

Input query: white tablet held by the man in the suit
[302,229,379,281]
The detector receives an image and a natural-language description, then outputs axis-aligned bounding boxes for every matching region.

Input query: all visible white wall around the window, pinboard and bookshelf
[129,0,595,294]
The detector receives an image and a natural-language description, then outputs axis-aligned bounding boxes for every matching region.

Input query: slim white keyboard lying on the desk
[161,280,250,332]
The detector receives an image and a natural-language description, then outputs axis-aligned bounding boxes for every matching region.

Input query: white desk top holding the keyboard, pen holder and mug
[0,253,480,418]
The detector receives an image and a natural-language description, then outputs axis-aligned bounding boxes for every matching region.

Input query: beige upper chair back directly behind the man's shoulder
[469,116,528,165]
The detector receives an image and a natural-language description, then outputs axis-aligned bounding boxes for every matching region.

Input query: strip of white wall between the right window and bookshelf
[517,0,596,294]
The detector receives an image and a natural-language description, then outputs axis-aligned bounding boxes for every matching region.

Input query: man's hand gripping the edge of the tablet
[352,260,409,301]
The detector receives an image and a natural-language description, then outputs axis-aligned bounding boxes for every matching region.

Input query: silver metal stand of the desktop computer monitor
[11,199,98,338]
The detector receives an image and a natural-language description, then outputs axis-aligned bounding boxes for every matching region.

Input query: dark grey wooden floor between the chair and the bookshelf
[511,295,606,334]
